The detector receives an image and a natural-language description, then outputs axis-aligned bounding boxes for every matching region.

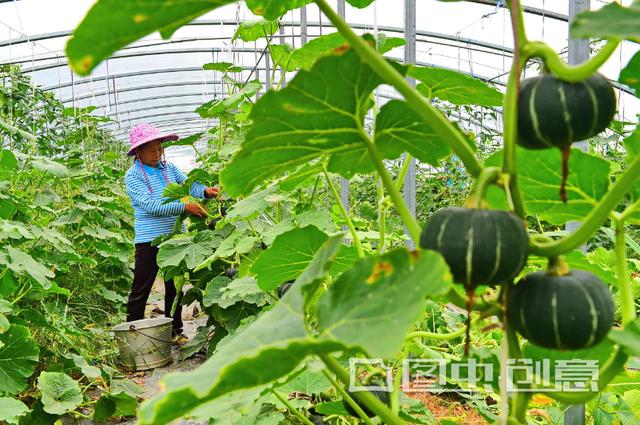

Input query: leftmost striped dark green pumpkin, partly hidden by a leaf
[420,207,529,289]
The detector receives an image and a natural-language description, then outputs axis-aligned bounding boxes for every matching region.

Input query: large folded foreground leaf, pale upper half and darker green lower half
[138,235,343,425]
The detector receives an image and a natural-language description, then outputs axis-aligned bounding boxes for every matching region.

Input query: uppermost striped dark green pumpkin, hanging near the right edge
[518,74,616,149]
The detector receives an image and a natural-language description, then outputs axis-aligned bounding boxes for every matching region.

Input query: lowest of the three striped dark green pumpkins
[508,270,613,350]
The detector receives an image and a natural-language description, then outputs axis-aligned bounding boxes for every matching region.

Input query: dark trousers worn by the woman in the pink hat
[127,242,182,333]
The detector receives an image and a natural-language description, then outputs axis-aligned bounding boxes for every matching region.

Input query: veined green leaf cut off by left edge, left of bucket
[0,325,40,395]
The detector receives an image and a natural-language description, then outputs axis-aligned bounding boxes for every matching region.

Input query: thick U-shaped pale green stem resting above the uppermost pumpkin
[522,38,620,82]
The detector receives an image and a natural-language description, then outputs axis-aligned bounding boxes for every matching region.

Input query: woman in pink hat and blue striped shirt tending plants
[124,124,218,337]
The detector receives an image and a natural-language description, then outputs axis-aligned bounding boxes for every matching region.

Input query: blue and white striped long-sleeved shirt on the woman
[124,160,206,243]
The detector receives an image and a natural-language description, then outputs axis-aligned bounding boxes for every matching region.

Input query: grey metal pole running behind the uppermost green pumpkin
[564,0,591,425]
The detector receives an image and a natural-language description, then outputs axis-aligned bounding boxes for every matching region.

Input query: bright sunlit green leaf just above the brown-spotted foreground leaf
[251,226,328,291]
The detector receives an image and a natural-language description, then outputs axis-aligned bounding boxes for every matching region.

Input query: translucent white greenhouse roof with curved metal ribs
[0,0,640,164]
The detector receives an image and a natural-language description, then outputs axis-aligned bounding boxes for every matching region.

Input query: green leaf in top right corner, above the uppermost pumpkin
[571,1,640,38]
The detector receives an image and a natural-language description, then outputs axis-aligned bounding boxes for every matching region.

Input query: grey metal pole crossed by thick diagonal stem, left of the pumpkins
[403,0,416,249]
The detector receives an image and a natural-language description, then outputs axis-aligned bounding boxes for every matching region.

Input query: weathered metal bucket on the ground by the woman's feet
[112,317,173,371]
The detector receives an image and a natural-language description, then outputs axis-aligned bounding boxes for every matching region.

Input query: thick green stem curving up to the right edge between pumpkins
[529,156,640,257]
